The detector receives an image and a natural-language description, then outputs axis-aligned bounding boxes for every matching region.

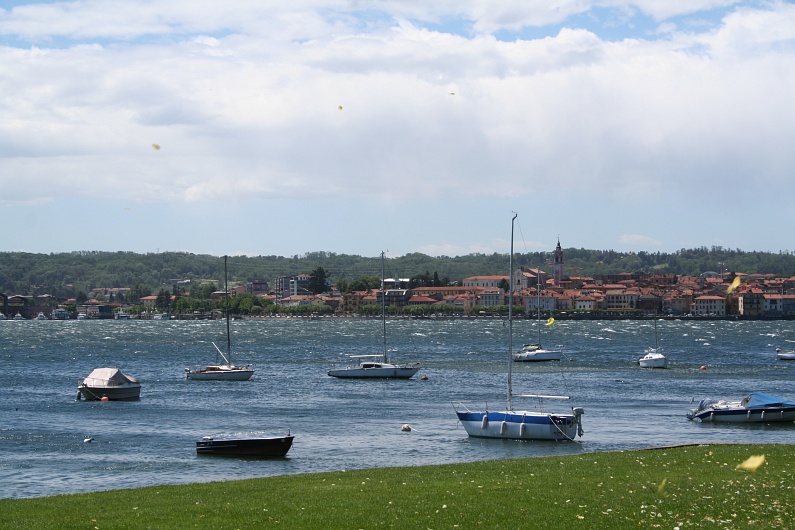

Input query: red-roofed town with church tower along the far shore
[0,242,795,320]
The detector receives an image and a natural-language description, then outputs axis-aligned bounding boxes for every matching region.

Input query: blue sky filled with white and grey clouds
[0,0,795,256]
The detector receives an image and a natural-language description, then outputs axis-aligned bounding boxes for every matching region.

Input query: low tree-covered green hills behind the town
[0,247,795,298]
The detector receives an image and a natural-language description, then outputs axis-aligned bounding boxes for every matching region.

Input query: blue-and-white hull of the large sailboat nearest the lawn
[456,411,581,441]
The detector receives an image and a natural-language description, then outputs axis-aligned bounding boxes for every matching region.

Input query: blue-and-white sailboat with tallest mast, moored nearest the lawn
[454,214,585,441]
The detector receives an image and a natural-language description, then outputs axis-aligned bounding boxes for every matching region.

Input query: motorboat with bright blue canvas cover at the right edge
[687,392,795,423]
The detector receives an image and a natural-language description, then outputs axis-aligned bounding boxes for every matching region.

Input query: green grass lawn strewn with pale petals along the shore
[0,442,795,530]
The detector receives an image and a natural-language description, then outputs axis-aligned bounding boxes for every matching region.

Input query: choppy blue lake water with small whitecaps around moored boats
[0,318,795,498]
